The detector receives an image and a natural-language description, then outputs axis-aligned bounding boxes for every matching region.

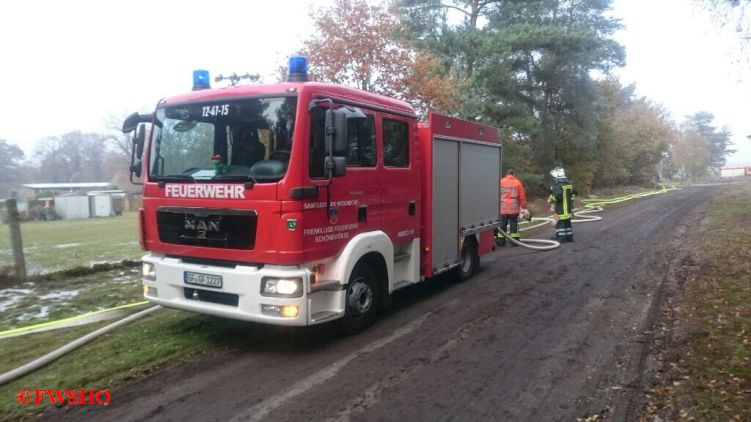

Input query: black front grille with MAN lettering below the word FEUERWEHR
[156,207,258,250]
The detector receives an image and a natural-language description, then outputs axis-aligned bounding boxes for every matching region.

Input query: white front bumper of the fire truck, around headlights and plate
[142,253,345,326]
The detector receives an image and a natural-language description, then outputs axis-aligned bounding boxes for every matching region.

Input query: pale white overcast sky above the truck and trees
[0,0,751,165]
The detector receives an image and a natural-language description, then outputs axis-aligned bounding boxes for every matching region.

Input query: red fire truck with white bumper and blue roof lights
[123,57,501,332]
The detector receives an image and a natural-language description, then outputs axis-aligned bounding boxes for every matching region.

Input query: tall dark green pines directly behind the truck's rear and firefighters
[399,0,648,190]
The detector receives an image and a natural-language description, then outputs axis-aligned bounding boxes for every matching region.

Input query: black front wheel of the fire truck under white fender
[340,264,379,334]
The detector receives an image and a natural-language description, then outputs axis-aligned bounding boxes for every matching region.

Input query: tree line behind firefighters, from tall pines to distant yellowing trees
[302,0,730,193]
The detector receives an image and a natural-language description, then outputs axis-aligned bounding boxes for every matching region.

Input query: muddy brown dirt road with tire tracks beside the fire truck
[47,187,715,421]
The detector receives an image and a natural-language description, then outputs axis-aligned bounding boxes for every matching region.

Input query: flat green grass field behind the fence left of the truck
[0,212,141,274]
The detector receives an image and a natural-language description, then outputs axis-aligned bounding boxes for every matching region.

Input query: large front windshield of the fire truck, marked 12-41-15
[149,97,297,182]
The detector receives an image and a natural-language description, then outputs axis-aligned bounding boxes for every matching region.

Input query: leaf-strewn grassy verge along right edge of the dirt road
[643,183,751,420]
